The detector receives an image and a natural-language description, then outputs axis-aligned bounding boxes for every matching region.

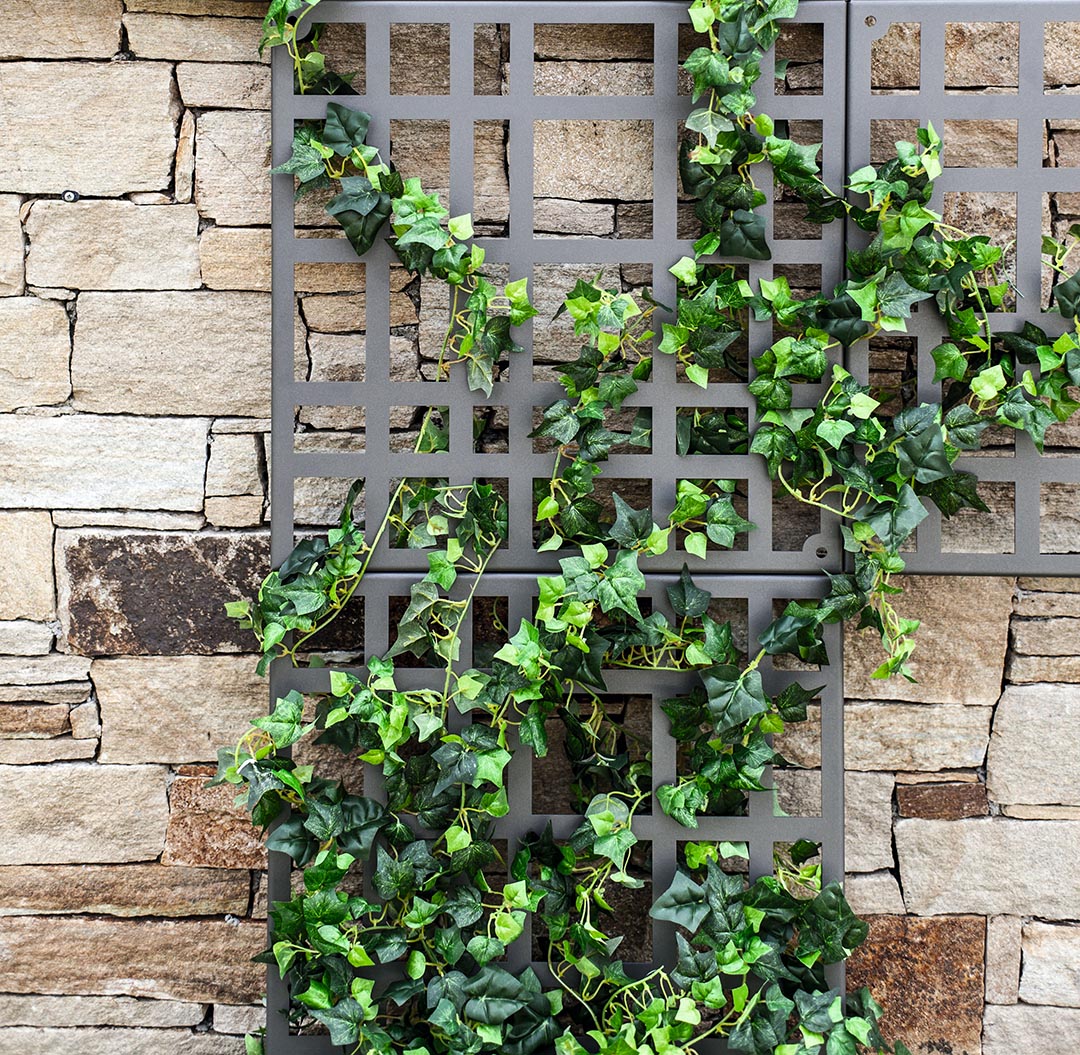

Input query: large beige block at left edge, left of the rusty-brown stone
[0,765,168,863]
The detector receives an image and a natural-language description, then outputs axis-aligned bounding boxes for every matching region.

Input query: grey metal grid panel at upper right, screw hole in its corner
[847,0,1080,574]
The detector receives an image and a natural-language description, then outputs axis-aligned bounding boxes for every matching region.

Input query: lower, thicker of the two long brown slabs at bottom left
[0,916,266,1003]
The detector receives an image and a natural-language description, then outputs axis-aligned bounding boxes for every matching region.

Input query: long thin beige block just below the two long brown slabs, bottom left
[0,995,205,1028]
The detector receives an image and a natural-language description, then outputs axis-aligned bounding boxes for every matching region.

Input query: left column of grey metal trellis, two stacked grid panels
[268,0,847,1055]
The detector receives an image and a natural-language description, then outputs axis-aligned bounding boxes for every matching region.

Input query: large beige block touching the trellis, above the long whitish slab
[71,292,270,418]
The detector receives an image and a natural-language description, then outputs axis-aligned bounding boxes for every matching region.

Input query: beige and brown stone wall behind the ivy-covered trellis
[0,8,1080,1055]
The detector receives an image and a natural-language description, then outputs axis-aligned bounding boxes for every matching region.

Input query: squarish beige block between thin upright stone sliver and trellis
[195,110,270,227]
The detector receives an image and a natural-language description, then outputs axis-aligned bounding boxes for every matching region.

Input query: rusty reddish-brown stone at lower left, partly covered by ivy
[162,768,267,868]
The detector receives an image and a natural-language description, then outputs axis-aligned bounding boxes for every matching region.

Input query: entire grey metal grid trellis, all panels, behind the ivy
[268,0,1080,1055]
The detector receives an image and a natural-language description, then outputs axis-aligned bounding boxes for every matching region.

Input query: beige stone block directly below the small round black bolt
[26,201,200,289]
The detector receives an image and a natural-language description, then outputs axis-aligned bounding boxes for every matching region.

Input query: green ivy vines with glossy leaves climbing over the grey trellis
[217,0,1080,1055]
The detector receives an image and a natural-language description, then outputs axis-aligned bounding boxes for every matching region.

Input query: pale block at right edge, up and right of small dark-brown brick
[986,685,1080,806]
